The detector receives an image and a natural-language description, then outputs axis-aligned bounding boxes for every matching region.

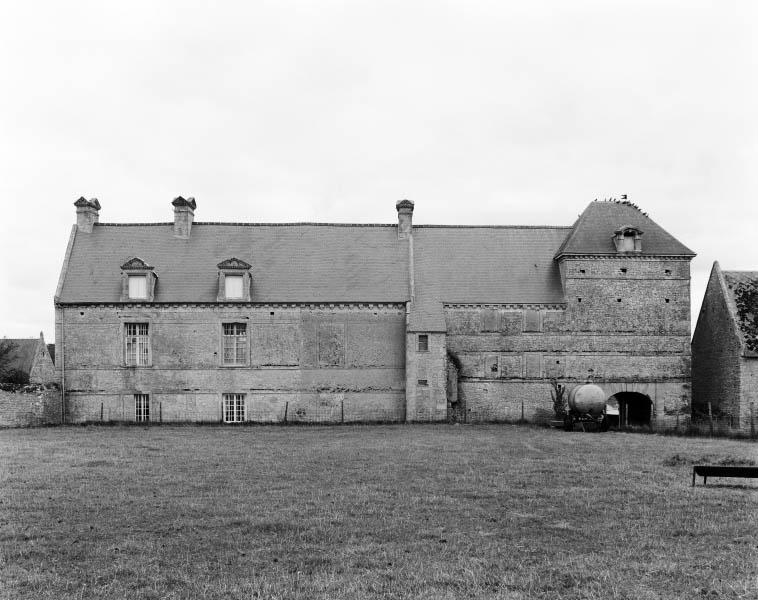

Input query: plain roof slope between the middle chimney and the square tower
[410,226,571,331]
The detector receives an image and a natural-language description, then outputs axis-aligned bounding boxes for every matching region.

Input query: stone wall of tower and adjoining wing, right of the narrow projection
[445,258,691,427]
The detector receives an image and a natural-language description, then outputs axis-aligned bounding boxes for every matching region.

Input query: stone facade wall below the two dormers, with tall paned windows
[56,304,405,423]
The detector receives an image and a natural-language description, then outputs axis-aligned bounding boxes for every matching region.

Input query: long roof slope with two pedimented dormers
[59,223,409,303]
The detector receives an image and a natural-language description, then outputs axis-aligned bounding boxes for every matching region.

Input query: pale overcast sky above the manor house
[0,0,758,342]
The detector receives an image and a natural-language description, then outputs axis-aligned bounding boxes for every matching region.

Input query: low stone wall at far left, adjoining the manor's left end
[0,384,61,427]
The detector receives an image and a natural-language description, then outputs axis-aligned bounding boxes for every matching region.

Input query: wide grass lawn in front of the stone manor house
[0,425,758,600]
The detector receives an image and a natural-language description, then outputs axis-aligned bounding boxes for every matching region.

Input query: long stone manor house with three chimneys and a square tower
[55,197,694,426]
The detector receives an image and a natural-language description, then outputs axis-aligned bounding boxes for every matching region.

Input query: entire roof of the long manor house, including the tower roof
[57,202,693,331]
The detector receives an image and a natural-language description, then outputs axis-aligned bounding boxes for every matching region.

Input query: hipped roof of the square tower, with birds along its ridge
[556,202,695,256]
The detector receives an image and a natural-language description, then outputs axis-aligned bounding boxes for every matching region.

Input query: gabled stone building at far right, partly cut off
[692,262,758,431]
